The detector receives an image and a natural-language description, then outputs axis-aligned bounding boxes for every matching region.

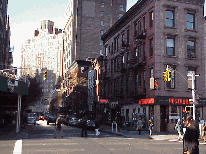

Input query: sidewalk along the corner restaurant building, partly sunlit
[100,125,178,140]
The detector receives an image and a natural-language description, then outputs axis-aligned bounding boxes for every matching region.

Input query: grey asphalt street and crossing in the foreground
[0,121,206,154]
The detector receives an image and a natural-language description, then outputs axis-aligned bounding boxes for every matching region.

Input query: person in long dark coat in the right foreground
[183,115,199,154]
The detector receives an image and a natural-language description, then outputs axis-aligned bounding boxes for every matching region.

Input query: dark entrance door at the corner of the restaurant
[160,105,169,132]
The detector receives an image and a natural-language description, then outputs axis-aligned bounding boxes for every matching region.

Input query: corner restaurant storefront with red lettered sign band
[139,97,191,132]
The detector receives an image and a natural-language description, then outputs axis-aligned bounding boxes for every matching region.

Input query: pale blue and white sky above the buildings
[8,0,205,67]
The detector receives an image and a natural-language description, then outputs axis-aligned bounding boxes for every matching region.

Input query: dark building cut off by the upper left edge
[0,0,13,69]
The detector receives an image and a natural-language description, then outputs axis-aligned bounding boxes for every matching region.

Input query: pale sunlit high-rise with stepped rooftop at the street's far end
[21,20,63,110]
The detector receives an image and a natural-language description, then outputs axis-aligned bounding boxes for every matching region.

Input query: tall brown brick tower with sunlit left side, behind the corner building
[62,0,126,105]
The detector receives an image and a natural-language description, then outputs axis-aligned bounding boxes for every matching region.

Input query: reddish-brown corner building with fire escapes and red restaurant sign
[101,0,206,132]
